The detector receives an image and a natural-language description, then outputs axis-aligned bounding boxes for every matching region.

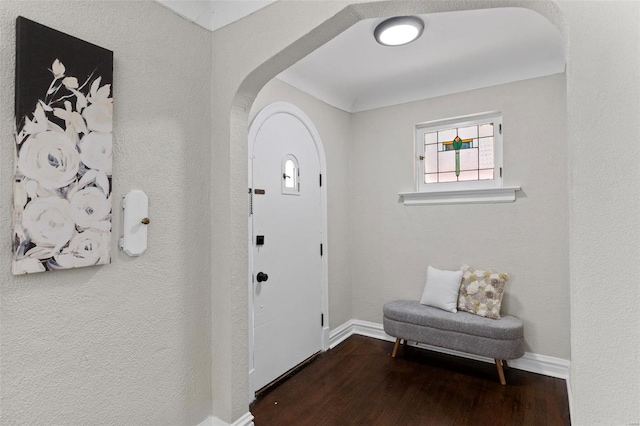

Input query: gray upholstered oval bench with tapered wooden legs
[383,300,524,385]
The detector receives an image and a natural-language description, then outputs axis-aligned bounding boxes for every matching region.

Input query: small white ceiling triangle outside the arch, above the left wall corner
[157,0,276,31]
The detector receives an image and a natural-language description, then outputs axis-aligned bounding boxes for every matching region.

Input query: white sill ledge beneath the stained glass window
[398,186,520,206]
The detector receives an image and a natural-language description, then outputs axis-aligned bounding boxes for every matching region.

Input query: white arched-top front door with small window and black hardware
[250,104,323,391]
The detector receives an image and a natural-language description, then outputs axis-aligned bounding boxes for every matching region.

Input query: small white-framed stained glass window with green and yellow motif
[416,113,502,193]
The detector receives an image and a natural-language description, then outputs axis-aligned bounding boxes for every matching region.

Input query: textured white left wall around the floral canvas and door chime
[0,0,212,425]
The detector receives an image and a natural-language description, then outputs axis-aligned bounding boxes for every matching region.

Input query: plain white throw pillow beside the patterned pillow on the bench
[420,266,462,312]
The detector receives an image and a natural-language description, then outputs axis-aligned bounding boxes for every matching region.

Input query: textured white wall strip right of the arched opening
[562,1,640,425]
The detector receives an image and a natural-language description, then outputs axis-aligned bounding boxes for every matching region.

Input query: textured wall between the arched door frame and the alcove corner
[249,79,353,329]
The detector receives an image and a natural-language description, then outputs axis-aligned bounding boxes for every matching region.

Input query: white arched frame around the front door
[247,102,329,401]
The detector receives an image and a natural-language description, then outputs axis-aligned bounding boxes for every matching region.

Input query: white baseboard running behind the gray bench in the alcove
[329,319,569,380]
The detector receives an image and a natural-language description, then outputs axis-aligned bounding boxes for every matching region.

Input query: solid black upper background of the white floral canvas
[15,16,113,128]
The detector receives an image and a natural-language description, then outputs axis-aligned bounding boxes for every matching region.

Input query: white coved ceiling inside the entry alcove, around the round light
[278,8,565,112]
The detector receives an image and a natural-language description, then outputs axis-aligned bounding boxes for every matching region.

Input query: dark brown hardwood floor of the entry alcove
[251,336,570,426]
